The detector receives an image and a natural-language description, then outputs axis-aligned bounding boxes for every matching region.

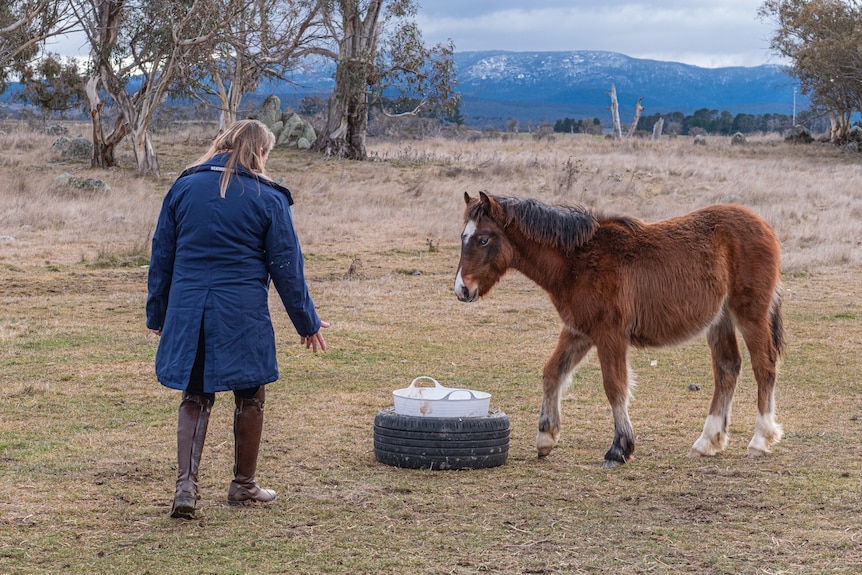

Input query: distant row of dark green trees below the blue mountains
[554,108,829,136]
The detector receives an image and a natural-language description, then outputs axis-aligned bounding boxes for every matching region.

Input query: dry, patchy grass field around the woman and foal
[0,125,862,575]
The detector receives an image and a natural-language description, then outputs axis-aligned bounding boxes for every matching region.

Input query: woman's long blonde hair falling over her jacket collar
[189,120,275,197]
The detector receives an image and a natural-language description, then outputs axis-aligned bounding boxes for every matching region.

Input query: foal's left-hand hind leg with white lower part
[688,308,742,457]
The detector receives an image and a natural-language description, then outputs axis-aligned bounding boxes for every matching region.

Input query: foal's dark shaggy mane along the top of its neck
[476,196,642,253]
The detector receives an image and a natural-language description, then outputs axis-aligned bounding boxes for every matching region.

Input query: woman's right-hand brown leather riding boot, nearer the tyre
[227,386,276,505]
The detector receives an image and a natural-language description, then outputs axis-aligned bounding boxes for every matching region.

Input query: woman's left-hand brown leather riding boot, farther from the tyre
[171,391,212,519]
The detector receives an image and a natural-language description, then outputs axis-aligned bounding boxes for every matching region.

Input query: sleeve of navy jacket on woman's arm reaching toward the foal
[266,194,320,337]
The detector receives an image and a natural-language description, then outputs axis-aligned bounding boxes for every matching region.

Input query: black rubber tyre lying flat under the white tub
[374,407,509,469]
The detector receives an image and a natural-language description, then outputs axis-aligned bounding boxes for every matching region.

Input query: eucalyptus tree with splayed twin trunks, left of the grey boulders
[71,0,234,175]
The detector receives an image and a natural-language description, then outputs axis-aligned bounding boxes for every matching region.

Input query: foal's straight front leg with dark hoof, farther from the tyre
[597,340,635,467]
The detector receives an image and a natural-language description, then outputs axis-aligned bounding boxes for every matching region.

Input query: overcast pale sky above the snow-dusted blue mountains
[417,0,782,68]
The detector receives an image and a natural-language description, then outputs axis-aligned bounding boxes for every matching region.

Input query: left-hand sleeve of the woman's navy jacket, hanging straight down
[147,188,177,329]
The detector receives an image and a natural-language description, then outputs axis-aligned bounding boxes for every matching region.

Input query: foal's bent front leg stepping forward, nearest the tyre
[536,327,593,457]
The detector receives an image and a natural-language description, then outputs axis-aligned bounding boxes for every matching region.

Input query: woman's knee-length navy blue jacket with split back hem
[147,154,320,393]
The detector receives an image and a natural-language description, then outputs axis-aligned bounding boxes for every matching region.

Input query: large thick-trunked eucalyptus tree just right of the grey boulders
[314,0,458,160]
